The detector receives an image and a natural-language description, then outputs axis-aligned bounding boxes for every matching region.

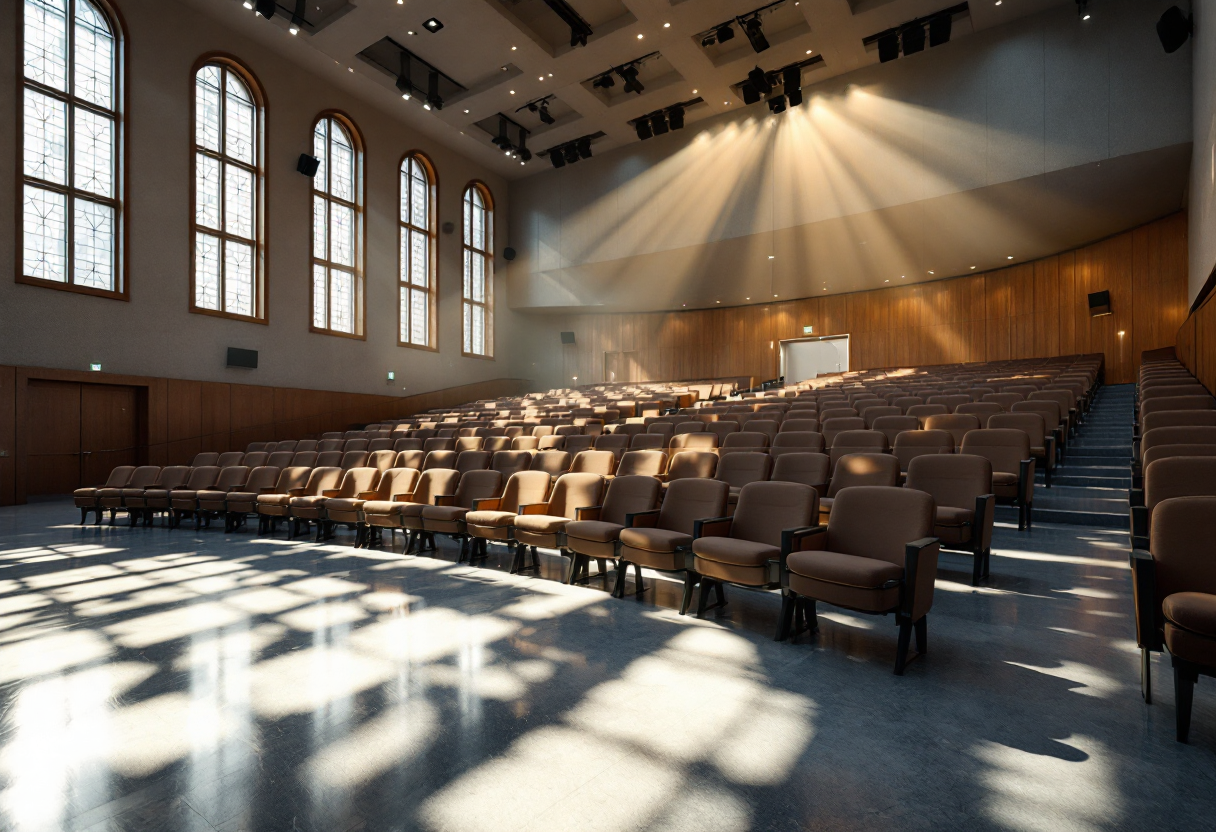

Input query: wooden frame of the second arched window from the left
[187,52,270,324]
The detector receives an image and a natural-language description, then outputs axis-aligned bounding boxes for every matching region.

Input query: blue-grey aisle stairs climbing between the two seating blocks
[997,384,1133,529]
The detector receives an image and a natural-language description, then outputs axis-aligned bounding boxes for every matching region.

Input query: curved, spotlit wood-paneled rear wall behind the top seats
[562,214,1186,383]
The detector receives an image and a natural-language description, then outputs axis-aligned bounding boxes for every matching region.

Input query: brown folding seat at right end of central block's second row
[905,454,996,586]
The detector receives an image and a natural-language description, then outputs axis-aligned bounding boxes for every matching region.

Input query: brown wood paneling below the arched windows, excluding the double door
[0,366,529,505]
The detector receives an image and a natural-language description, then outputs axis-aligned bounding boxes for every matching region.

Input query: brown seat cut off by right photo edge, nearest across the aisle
[1132,496,1216,742]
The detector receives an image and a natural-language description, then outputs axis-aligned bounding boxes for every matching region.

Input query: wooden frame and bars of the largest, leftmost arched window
[13,0,131,300]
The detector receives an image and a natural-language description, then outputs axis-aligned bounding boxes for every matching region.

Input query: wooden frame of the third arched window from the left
[308,109,367,341]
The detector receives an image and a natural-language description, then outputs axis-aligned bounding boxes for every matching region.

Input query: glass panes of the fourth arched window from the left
[398,153,438,349]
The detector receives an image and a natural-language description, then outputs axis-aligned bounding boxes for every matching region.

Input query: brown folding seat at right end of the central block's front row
[778,485,939,676]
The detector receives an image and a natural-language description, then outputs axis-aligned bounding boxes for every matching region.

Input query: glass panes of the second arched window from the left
[190,60,266,322]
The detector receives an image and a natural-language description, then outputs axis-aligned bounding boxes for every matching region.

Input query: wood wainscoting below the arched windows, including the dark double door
[0,366,529,505]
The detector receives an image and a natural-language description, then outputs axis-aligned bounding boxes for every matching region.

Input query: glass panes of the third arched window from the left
[313,113,364,338]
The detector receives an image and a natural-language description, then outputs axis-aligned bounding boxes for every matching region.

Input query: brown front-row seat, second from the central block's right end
[685,483,822,618]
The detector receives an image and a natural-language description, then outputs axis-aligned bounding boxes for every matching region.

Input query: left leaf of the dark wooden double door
[26,378,80,496]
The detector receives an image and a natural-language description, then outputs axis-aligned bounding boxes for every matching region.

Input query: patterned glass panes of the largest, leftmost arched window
[17,0,126,298]
